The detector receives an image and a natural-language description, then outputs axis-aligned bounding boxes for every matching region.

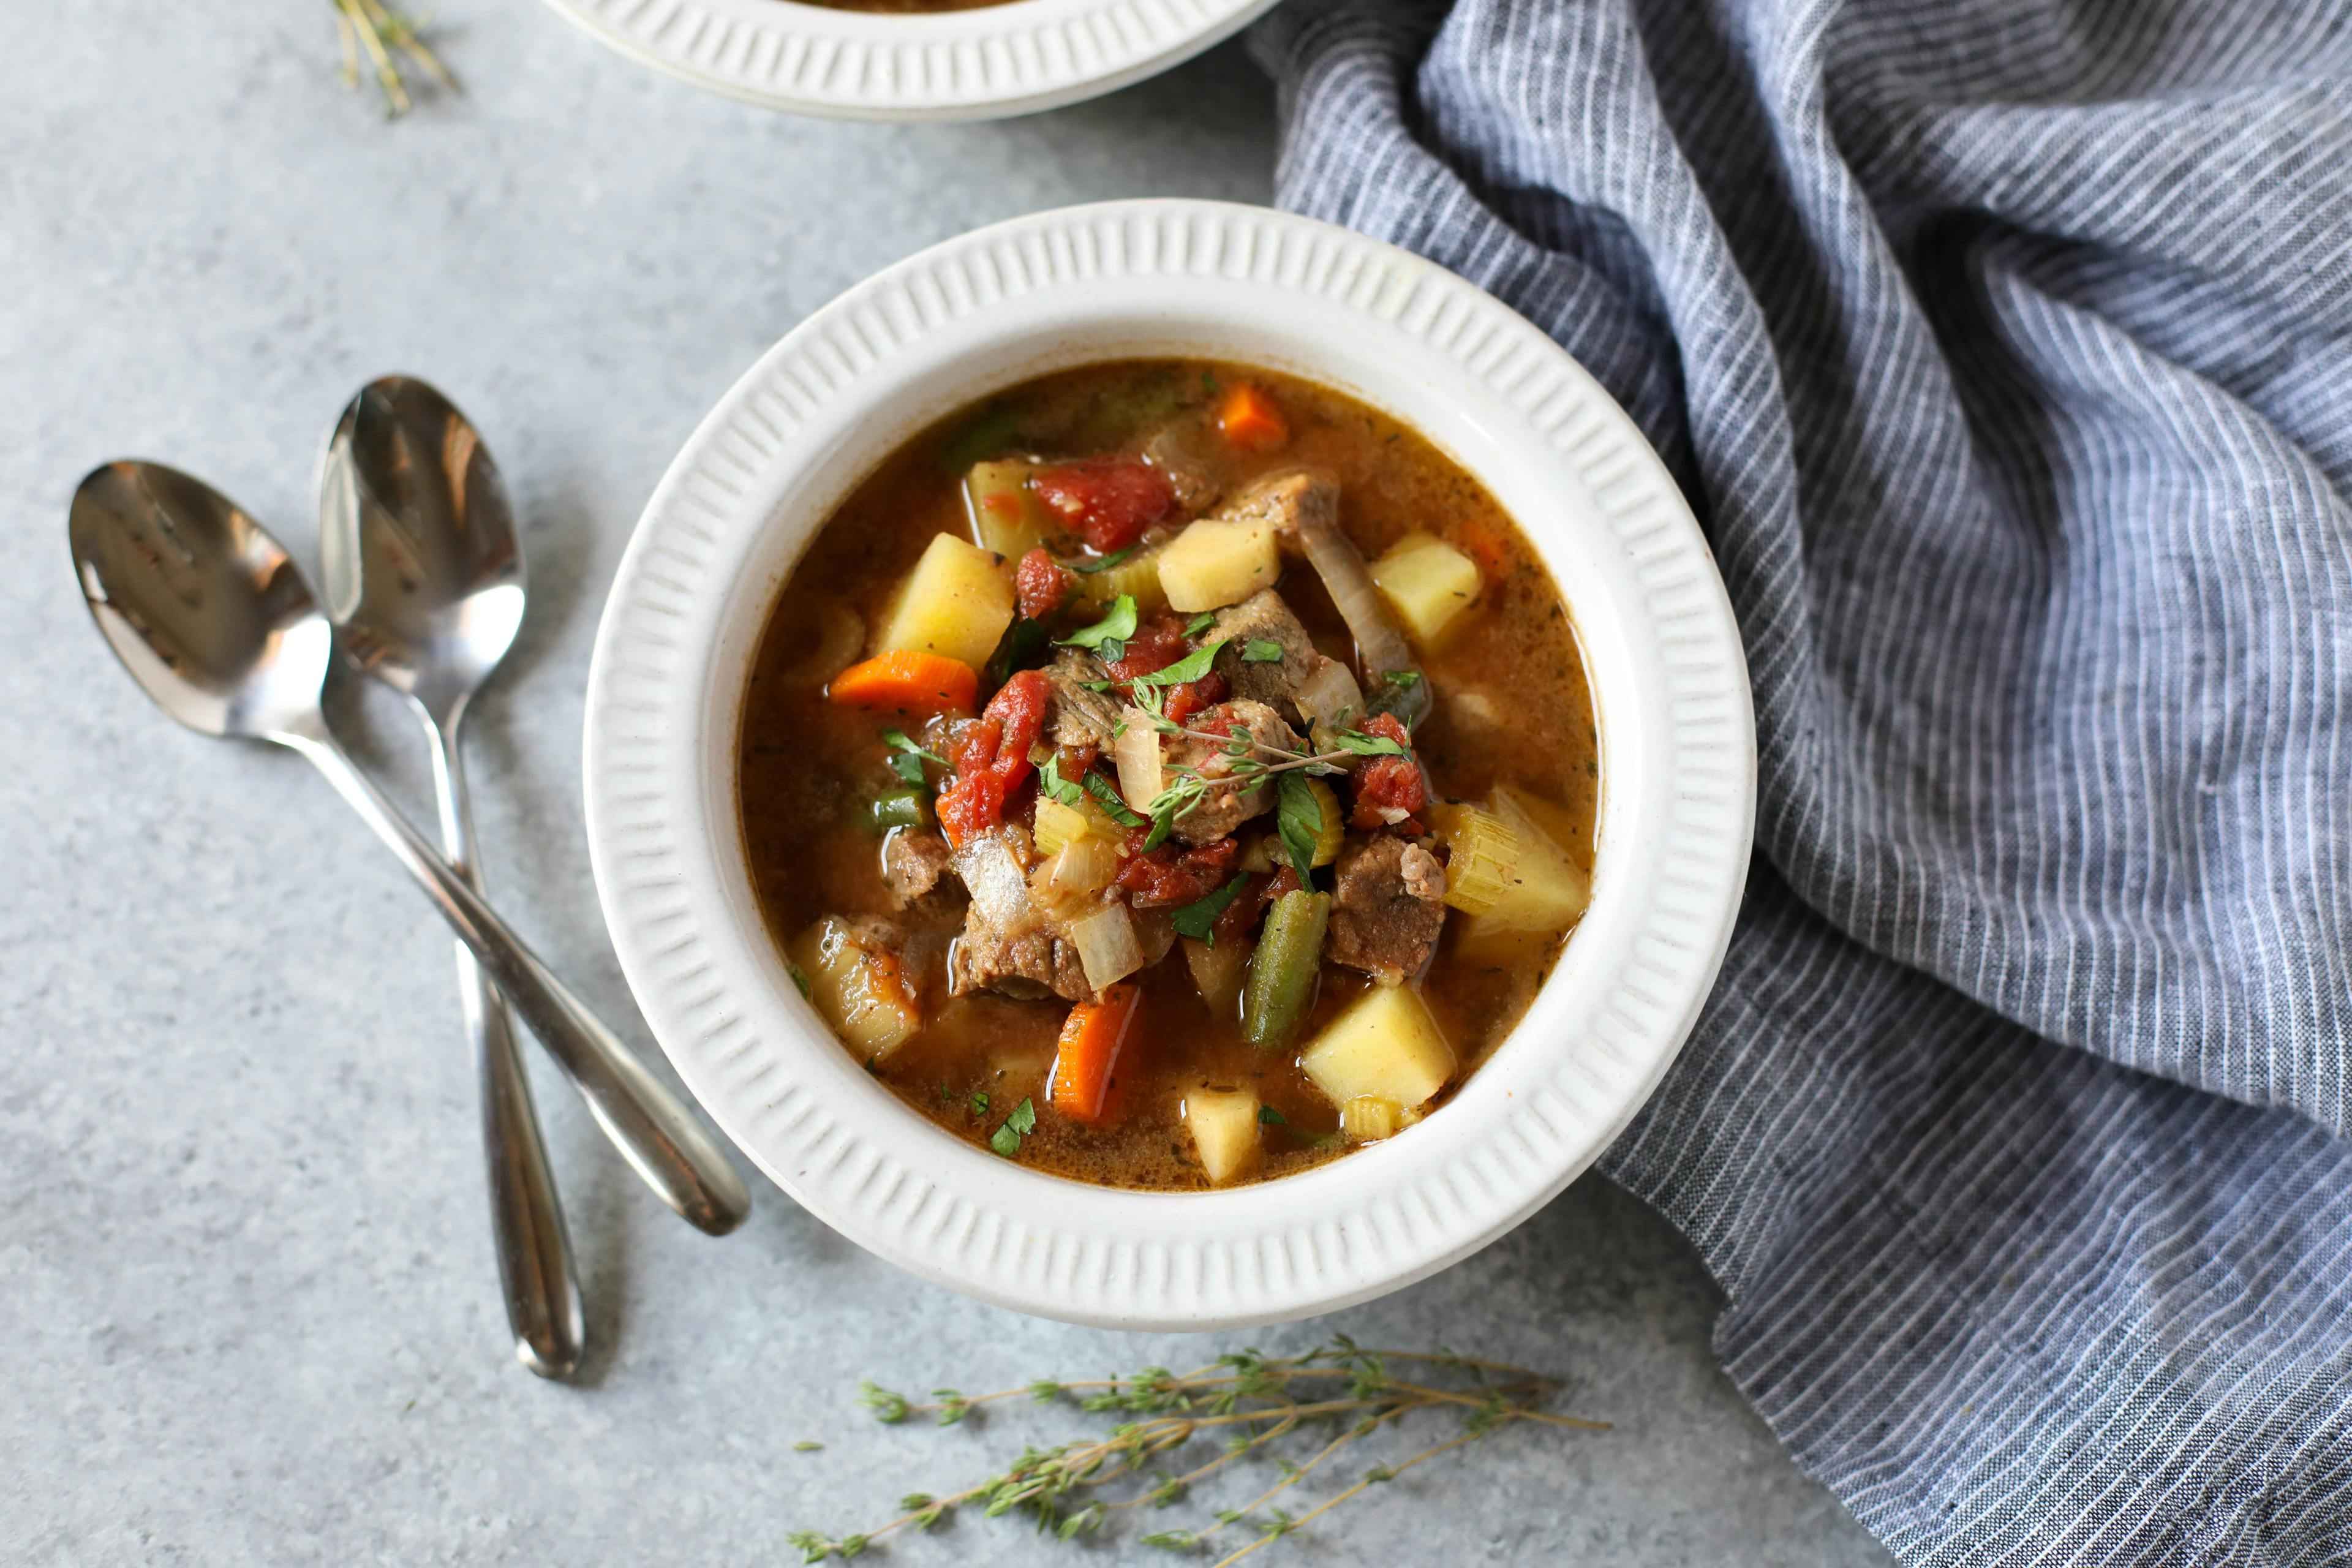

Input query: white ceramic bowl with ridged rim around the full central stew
[586,200,1755,1329]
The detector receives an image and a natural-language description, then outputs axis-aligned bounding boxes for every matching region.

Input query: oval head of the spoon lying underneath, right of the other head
[317,376,522,726]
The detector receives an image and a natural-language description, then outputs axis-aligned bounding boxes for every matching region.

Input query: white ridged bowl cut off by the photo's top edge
[548,0,1275,120]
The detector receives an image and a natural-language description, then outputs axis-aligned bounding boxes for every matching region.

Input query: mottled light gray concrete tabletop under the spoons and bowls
[0,0,1884,1568]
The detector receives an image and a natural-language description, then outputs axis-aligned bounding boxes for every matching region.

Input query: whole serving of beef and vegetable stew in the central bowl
[739,360,1599,1189]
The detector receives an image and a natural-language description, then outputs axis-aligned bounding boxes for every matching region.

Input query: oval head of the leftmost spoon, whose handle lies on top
[66,458,334,741]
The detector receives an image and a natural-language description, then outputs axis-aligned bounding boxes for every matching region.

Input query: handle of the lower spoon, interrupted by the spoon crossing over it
[423,715,588,1378]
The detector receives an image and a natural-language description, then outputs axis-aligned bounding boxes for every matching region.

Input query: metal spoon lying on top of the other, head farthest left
[68,461,750,1237]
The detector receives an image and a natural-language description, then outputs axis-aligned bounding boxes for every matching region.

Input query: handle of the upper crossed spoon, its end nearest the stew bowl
[273,724,750,1237]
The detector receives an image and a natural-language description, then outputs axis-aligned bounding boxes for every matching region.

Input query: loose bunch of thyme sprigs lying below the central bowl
[786,1335,1609,1568]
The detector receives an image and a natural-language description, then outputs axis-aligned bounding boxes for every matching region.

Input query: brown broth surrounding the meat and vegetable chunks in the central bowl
[739,360,1599,1189]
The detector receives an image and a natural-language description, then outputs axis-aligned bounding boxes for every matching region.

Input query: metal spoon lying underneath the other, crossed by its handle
[317,376,586,1378]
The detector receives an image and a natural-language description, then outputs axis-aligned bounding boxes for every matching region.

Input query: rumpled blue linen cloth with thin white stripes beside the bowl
[1254,0,2352,1563]
